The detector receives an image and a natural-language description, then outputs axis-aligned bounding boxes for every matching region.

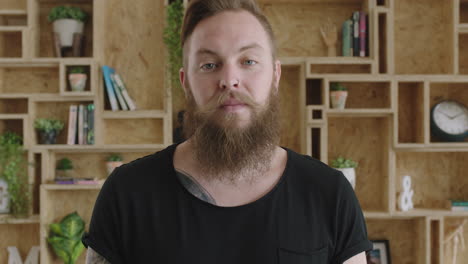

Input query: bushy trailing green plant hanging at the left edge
[0,131,31,217]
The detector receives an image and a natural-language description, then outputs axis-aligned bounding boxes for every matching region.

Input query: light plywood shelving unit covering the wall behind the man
[0,0,468,264]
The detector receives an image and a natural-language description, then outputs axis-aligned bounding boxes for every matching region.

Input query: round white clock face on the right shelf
[432,101,468,135]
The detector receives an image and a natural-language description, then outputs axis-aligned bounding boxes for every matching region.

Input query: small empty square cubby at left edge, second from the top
[0,30,24,58]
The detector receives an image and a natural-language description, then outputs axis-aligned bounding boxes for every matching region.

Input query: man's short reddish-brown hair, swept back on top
[181,0,276,64]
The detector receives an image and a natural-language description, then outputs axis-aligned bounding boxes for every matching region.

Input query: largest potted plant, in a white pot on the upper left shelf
[47,6,88,47]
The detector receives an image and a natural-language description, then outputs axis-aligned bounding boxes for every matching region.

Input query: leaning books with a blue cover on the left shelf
[102,65,136,111]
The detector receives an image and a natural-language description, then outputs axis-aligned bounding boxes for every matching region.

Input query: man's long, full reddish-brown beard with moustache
[184,83,280,184]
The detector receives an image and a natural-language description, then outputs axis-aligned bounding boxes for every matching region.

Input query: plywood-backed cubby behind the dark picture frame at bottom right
[366,217,431,264]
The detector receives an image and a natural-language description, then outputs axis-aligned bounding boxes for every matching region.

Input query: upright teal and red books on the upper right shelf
[342,11,369,57]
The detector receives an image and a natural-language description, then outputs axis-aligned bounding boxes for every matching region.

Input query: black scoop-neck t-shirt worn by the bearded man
[82,144,372,264]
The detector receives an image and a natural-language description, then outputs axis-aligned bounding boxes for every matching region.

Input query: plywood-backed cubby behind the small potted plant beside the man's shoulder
[327,116,391,212]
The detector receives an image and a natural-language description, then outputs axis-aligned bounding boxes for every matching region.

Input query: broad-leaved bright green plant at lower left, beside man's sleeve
[47,212,85,264]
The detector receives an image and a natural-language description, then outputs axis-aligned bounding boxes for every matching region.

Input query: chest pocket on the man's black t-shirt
[278,246,328,264]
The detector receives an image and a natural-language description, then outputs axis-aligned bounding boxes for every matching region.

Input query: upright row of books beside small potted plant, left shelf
[67,104,94,145]
